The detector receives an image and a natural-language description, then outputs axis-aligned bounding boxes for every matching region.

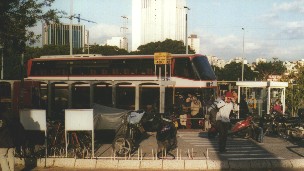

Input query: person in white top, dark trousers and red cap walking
[217,92,233,153]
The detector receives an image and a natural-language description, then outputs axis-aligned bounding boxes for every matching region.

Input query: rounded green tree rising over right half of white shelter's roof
[255,61,286,80]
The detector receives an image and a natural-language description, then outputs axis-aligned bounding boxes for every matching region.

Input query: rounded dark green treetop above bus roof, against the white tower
[131,39,195,55]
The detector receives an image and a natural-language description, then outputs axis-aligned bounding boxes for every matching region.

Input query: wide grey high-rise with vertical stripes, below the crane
[42,23,89,48]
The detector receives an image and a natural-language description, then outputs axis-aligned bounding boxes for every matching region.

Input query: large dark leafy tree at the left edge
[0,0,64,79]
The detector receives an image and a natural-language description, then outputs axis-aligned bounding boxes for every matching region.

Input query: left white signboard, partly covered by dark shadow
[19,109,46,131]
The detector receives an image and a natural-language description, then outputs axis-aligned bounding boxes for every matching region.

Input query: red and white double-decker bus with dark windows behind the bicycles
[1,54,217,119]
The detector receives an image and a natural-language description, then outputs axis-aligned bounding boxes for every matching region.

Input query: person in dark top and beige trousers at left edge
[0,104,15,171]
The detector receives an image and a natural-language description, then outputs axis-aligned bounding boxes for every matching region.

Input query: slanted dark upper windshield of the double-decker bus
[192,56,216,80]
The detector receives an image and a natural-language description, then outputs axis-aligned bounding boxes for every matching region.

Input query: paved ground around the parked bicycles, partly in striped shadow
[4,130,304,171]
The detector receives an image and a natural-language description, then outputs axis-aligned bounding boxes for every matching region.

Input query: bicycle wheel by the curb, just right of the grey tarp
[112,137,132,157]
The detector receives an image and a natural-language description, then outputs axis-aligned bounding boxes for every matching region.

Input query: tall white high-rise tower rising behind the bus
[132,0,188,51]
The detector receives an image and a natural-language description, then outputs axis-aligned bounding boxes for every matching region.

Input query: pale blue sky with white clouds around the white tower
[36,0,304,62]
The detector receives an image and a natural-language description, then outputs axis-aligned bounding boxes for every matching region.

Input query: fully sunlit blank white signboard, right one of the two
[65,109,94,131]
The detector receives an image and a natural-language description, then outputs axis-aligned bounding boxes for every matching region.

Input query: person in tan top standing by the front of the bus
[190,96,202,129]
